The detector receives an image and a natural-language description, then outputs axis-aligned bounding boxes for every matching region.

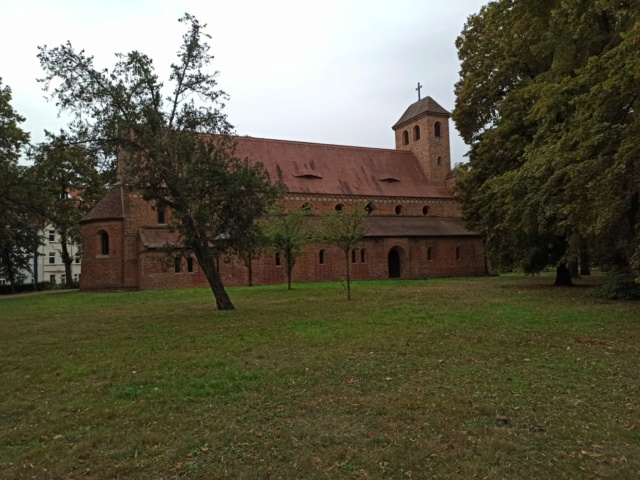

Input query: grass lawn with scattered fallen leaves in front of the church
[0,276,640,479]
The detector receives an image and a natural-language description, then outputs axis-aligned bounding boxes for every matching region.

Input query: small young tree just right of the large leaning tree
[265,205,312,290]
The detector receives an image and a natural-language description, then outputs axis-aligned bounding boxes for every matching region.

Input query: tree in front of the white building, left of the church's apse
[30,132,106,287]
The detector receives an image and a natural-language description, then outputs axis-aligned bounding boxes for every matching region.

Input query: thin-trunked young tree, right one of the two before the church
[320,208,367,300]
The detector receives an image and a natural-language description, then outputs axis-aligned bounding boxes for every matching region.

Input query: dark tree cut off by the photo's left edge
[0,79,40,289]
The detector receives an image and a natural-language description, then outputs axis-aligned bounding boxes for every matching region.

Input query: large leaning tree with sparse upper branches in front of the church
[39,14,276,310]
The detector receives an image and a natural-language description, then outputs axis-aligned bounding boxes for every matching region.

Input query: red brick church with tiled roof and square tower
[80,97,487,291]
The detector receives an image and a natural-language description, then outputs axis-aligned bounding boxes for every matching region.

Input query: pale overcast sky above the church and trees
[0,0,488,163]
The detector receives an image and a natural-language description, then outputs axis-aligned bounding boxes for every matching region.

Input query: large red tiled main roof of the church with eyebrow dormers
[236,137,452,198]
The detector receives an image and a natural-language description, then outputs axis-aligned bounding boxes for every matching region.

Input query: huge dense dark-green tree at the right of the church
[453,0,640,284]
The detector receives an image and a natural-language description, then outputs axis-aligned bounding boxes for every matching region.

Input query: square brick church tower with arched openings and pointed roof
[392,97,451,187]
